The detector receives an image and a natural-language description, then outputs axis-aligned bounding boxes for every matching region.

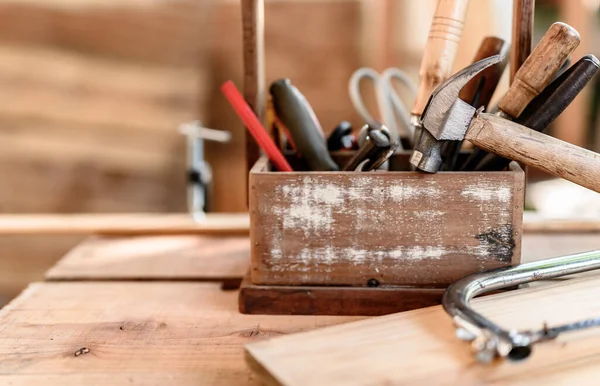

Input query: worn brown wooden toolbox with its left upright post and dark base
[239,0,524,315]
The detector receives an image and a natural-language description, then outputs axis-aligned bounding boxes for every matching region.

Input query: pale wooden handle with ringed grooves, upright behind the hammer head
[411,0,469,116]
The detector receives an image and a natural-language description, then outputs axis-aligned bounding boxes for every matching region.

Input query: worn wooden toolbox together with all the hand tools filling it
[222,0,600,315]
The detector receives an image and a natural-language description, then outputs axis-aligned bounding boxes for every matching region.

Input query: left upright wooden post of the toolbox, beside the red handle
[241,0,267,179]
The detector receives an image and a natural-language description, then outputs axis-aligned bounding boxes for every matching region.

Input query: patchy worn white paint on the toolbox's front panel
[256,173,515,284]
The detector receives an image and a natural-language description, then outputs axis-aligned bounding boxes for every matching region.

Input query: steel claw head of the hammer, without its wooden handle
[410,55,504,173]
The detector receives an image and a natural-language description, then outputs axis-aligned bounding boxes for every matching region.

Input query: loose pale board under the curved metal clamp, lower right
[247,274,600,386]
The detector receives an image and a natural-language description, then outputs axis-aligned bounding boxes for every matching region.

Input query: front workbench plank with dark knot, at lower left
[0,282,358,386]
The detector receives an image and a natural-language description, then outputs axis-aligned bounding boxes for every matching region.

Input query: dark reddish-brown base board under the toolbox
[239,277,444,316]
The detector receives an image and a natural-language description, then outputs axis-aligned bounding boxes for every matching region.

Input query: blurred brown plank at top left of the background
[0,0,213,66]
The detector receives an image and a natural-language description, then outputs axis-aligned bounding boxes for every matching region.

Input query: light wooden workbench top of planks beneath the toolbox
[0,233,600,385]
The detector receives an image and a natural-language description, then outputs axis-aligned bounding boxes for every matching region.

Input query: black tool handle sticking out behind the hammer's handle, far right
[475,55,599,171]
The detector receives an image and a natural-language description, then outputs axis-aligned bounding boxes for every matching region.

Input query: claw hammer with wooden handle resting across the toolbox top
[410,55,600,192]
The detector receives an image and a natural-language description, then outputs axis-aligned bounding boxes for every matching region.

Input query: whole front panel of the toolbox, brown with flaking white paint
[250,158,524,286]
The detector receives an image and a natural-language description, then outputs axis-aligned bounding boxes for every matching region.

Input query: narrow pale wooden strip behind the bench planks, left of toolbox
[0,213,249,235]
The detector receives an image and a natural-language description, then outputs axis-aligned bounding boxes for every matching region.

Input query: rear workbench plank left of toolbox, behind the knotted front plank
[46,235,250,285]
